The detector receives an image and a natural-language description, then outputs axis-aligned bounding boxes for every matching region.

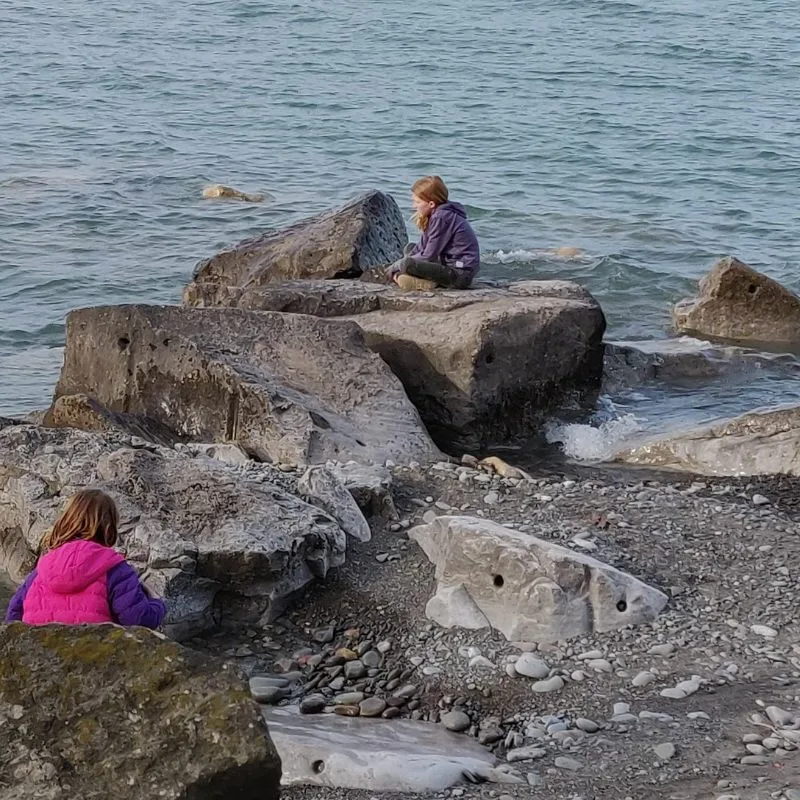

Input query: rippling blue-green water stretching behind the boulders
[0,0,800,455]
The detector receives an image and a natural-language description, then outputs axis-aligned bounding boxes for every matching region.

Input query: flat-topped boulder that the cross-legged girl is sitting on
[183,281,605,452]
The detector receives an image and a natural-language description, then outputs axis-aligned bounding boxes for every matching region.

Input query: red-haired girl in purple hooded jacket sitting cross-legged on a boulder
[387,175,481,290]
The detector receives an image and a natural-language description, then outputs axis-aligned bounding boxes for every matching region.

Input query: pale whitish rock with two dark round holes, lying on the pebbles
[409,517,667,642]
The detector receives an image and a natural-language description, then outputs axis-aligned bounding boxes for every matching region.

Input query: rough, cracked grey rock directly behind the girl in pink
[0,425,346,638]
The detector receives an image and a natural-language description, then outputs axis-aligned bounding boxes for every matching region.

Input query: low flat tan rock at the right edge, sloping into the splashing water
[614,407,800,475]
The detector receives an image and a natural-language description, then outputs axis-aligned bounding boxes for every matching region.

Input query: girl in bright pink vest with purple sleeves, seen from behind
[5,490,166,628]
